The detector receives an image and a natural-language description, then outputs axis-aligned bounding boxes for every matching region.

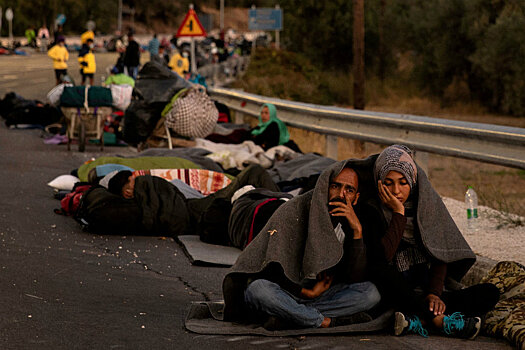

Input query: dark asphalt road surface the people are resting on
[0,54,511,350]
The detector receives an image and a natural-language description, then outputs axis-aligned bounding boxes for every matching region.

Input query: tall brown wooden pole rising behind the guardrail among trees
[353,0,365,109]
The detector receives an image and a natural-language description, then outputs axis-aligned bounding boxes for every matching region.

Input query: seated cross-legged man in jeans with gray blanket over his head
[223,162,380,330]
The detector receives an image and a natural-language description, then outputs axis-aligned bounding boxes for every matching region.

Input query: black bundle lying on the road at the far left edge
[0,92,62,129]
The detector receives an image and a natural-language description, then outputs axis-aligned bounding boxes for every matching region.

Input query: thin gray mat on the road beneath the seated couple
[184,301,393,337]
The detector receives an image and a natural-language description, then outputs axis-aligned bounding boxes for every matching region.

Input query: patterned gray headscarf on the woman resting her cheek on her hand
[374,145,417,189]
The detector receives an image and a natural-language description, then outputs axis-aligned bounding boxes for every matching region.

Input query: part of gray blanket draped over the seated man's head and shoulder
[223,162,356,321]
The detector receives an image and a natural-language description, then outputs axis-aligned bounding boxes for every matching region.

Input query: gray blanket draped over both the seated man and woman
[223,155,475,321]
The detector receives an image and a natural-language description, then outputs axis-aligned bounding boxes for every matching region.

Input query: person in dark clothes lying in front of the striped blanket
[102,165,279,245]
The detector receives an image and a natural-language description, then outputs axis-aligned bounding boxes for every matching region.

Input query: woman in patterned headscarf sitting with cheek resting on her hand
[363,145,499,339]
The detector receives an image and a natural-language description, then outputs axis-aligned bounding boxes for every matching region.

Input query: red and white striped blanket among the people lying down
[133,169,231,196]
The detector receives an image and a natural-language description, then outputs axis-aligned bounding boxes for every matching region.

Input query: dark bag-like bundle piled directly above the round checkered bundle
[135,61,191,104]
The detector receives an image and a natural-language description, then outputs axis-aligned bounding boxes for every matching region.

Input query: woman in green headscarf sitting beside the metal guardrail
[251,103,290,151]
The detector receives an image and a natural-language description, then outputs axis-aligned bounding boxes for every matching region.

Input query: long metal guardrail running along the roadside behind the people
[209,88,525,169]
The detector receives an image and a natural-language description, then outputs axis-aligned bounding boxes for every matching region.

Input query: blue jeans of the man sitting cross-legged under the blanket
[244,279,381,328]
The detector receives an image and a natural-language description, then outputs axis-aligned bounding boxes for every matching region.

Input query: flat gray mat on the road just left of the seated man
[177,235,241,266]
